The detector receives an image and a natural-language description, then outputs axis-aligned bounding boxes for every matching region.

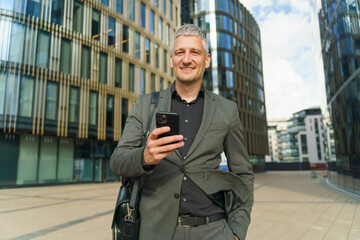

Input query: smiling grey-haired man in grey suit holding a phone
[111,24,253,240]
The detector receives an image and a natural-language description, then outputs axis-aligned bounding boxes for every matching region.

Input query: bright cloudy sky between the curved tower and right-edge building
[240,0,326,120]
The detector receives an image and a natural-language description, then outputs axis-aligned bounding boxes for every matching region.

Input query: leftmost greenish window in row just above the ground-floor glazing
[19,77,34,117]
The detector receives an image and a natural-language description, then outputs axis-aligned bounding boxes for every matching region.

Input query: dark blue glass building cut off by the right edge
[319,0,360,193]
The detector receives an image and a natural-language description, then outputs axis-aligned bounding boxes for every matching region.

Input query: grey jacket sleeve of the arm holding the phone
[110,96,150,177]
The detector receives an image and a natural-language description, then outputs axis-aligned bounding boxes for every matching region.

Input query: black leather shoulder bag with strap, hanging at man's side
[111,92,159,240]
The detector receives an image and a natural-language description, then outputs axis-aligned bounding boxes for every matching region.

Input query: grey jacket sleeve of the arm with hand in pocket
[224,103,254,240]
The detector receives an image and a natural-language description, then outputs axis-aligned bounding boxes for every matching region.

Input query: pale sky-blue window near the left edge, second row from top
[9,23,25,63]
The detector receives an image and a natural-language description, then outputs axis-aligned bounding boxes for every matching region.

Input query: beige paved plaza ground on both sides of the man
[0,171,360,240]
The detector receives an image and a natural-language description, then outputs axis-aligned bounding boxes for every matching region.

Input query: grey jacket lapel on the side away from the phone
[185,90,216,161]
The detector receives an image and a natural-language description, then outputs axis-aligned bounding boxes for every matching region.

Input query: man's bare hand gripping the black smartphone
[144,126,184,165]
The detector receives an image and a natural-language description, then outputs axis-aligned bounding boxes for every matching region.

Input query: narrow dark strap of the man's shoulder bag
[129,92,160,209]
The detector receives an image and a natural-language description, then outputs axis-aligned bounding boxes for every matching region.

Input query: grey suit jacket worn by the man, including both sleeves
[110,88,254,240]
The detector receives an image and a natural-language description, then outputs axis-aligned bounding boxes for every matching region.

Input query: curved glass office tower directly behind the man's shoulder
[190,0,268,171]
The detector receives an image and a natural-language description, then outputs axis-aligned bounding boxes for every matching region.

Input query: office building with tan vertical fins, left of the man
[0,0,180,186]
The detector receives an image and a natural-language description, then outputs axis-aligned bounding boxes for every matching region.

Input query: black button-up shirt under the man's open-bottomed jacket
[171,83,224,216]
